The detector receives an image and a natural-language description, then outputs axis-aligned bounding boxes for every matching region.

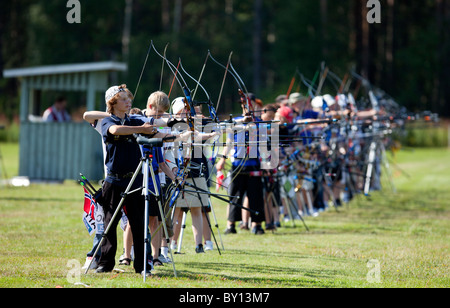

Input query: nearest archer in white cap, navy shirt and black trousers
[96,84,161,273]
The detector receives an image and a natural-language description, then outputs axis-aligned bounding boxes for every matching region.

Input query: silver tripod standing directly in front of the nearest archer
[85,136,177,282]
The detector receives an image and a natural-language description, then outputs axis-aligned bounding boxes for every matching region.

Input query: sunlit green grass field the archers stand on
[0,144,450,288]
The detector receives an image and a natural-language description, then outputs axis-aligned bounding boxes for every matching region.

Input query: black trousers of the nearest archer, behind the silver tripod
[98,181,146,273]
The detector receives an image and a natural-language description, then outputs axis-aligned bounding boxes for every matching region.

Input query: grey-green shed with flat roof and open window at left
[3,62,127,181]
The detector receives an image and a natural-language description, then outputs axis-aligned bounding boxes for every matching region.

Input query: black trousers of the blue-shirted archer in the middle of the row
[228,168,265,223]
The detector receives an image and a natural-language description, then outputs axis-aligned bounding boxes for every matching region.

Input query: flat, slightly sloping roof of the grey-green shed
[3,61,128,78]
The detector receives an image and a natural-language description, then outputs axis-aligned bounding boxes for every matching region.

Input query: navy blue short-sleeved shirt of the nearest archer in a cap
[102,115,144,186]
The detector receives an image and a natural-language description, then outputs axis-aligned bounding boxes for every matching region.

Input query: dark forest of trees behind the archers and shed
[0,0,450,117]
